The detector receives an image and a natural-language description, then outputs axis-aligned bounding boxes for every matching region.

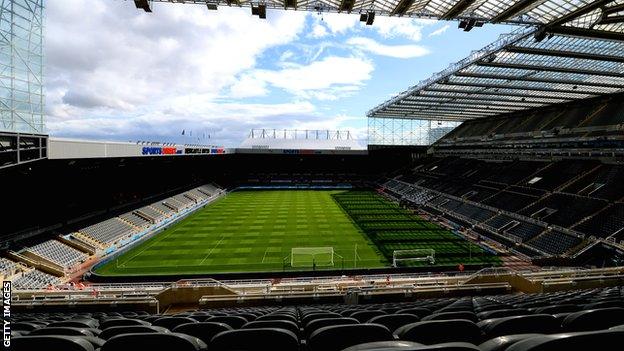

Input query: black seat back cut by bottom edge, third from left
[208,328,299,351]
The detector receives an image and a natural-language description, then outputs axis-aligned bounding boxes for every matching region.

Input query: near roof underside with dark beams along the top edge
[140,0,624,36]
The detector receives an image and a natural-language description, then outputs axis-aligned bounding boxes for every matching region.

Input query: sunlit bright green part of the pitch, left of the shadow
[97,190,387,275]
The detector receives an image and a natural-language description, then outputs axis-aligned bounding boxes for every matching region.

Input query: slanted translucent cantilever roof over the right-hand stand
[367,27,624,121]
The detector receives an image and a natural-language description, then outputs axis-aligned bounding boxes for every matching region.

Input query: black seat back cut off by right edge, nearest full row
[562,307,624,332]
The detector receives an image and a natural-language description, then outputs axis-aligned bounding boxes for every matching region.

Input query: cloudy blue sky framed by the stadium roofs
[45,0,513,146]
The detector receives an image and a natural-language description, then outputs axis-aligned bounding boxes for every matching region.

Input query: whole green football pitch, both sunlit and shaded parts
[95,190,498,276]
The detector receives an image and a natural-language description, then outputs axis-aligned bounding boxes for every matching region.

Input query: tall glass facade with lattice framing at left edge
[0,0,45,134]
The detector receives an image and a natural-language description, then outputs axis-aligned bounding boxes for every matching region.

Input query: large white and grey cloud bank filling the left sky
[46,0,306,119]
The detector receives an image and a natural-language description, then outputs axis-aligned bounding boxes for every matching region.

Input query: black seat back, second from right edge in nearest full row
[477,314,560,338]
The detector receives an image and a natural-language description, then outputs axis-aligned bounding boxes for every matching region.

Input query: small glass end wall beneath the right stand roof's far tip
[368,117,461,145]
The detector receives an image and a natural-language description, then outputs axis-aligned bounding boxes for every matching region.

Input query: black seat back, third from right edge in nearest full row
[394,319,481,345]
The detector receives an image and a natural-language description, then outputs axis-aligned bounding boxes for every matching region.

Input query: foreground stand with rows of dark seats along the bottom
[12,287,624,351]
